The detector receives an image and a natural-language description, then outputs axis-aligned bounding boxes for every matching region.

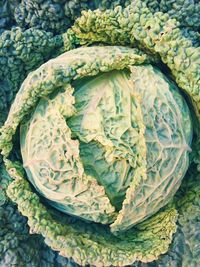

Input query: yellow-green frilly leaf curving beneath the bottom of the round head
[7,175,177,267]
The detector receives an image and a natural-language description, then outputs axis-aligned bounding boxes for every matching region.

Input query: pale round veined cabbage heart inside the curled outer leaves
[21,66,192,223]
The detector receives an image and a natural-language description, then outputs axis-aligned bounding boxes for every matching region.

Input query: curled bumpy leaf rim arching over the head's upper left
[0,46,149,157]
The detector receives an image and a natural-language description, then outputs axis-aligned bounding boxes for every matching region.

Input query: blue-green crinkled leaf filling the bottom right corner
[149,170,200,267]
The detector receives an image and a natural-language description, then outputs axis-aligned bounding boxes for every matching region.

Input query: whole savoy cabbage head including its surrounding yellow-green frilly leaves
[0,1,200,266]
